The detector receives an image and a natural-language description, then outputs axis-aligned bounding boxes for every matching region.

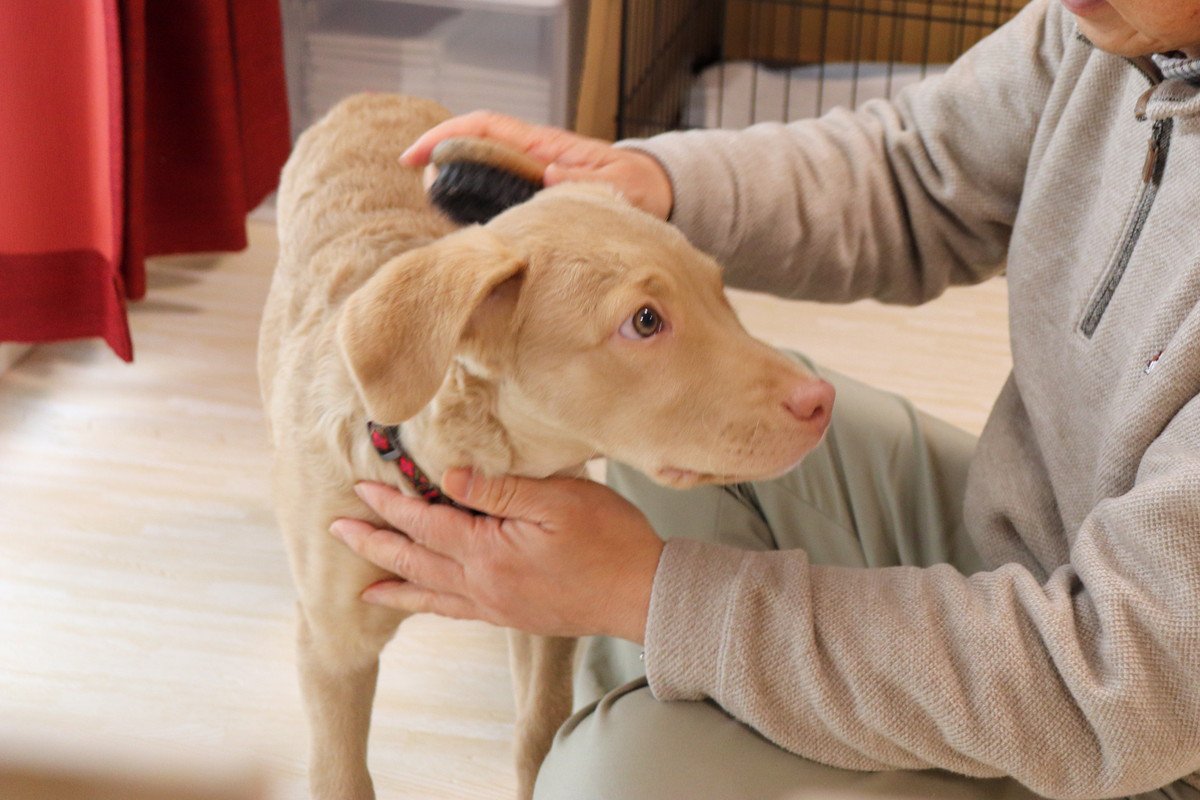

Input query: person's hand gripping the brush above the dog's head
[400,112,674,219]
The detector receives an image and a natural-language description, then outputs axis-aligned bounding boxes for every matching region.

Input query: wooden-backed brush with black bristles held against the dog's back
[428,137,546,225]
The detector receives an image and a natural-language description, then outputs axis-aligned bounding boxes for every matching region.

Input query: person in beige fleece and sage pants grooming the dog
[334,0,1200,800]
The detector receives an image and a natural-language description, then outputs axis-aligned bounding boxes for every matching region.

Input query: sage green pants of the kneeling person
[535,359,1200,800]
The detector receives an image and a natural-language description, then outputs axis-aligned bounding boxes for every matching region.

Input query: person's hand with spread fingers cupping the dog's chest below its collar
[330,469,662,644]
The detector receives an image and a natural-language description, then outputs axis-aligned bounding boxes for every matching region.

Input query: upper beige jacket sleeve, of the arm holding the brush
[622,0,1073,303]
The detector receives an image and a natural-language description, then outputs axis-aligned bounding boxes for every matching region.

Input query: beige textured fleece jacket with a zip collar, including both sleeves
[632,0,1200,798]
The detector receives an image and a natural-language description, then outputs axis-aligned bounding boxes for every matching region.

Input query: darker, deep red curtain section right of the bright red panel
[136,0,290,261]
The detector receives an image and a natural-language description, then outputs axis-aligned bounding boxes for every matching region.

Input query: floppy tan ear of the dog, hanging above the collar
[337,225,526,425]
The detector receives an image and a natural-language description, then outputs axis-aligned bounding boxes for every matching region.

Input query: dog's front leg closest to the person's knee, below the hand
[509,630,576,800]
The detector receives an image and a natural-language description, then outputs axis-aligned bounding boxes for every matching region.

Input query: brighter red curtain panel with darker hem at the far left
[0,0,131,357]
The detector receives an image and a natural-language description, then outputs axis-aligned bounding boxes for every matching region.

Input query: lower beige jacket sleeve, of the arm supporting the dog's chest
[646,398,1200,798]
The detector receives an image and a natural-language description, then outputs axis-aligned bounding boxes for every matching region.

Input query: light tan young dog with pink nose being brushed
[259,95,833,800]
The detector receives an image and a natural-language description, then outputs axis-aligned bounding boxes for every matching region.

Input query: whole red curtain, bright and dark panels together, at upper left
[0,0,289,360]
